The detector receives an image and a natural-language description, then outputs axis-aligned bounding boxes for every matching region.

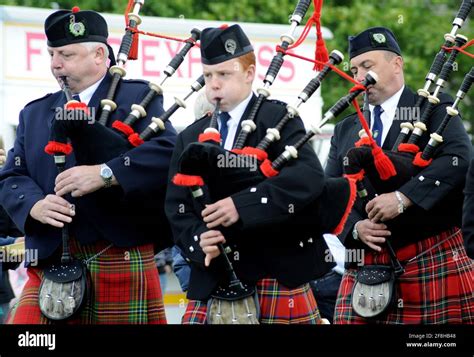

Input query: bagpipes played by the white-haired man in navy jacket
[45,0,204,165]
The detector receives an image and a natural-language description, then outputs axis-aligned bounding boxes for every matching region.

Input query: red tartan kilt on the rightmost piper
[334,228,474,324]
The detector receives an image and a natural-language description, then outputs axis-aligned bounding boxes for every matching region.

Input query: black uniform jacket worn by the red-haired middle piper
[166,96,334,300]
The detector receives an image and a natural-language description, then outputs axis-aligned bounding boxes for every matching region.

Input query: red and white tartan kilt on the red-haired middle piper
[182,279,321,325]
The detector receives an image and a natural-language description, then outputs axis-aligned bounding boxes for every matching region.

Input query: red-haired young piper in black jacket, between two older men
[165,25,331,324]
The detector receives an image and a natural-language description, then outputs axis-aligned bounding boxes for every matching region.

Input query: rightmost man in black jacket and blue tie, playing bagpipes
[326,27,474,324]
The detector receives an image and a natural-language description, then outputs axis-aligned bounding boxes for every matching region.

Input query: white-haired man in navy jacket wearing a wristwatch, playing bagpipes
[0,7,176,324]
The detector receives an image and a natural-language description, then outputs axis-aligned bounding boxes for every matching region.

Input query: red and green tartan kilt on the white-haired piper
[8,240,166,324]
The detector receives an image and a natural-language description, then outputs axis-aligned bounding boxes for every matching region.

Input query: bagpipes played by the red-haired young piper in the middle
[172,1,377,323]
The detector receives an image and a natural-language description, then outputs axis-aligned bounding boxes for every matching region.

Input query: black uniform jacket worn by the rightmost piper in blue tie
[326,87,471,248]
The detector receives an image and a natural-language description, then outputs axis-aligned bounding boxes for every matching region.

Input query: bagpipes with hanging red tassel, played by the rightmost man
[344,0,474,237]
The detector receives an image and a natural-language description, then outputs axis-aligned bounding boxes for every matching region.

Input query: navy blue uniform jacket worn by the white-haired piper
[0,75,176,259]
